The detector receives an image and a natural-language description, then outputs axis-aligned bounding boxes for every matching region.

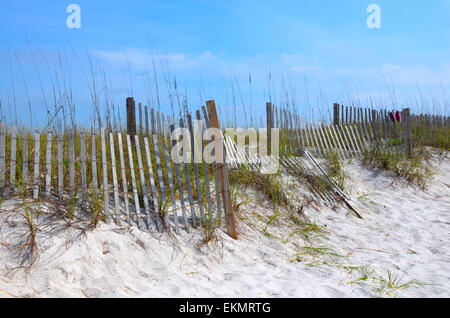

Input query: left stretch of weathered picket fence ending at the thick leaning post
[0,101,237,238]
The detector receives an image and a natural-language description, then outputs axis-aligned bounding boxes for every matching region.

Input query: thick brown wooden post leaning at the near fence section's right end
[206,100,237,239]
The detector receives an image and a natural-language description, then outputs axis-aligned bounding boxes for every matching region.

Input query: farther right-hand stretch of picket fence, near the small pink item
[266,103,450,158]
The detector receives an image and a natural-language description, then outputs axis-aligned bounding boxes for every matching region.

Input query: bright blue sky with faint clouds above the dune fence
[0,0,450,126]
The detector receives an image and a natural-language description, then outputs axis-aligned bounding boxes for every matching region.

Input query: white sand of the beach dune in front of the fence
[0,150,450,297]
